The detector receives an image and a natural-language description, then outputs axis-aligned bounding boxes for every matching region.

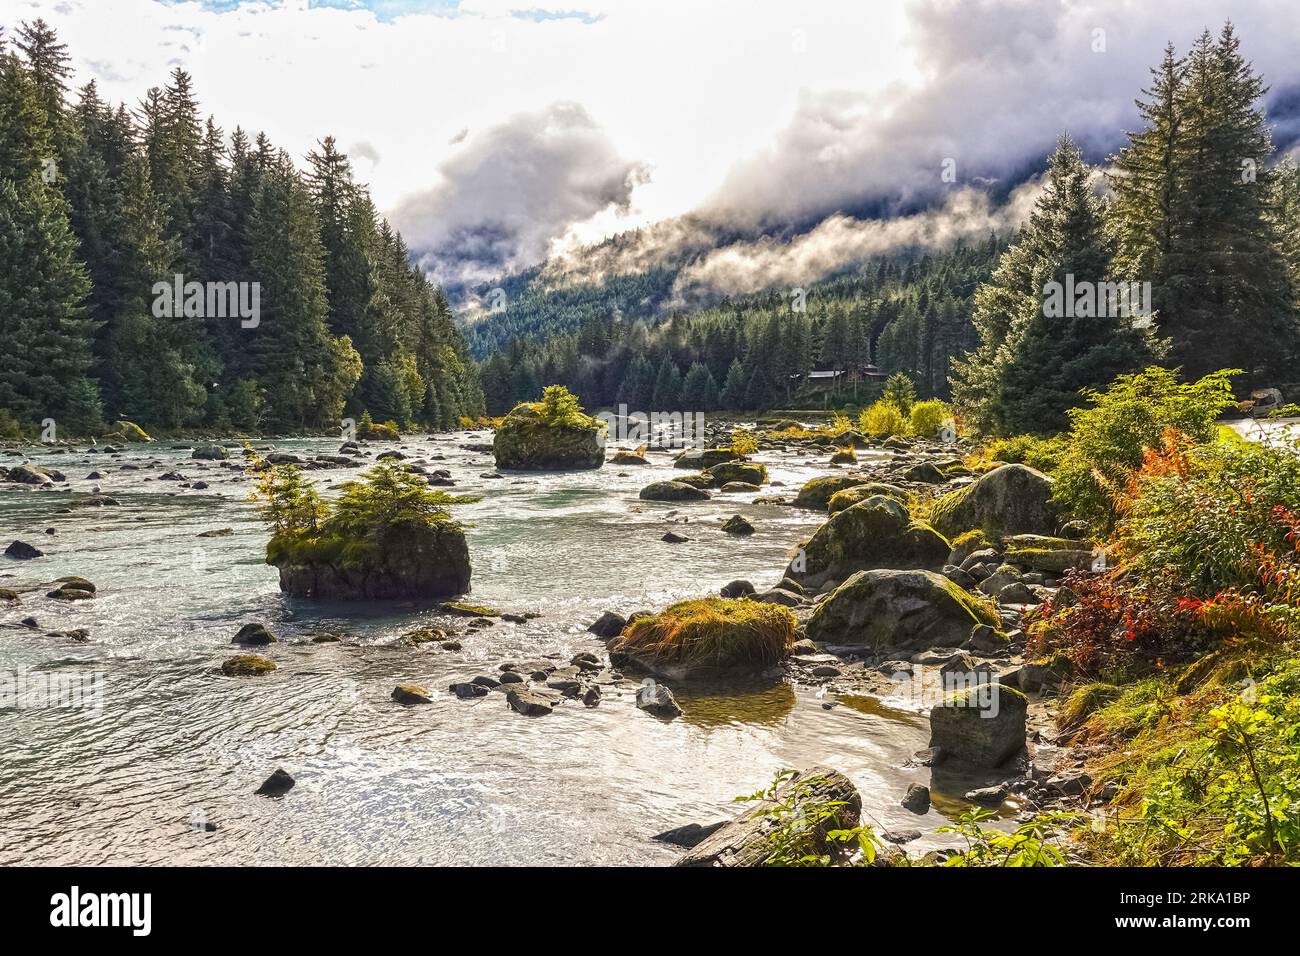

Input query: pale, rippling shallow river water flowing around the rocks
[0,433,967,865]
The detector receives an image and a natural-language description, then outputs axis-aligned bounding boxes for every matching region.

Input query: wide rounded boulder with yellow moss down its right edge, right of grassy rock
[807,570,1001,650]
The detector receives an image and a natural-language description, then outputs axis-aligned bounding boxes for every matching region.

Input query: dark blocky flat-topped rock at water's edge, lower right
[930,683,1028,767]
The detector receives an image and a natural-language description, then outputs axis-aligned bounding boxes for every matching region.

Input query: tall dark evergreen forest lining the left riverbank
[0,20,482,434]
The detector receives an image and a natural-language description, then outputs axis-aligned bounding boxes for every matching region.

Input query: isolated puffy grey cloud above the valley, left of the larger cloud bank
[391,103,649,285]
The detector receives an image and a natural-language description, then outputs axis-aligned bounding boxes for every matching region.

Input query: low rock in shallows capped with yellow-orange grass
[618,597,796,669]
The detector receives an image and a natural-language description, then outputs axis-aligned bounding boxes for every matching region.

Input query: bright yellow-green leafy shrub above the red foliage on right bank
[1054,367,1239,531]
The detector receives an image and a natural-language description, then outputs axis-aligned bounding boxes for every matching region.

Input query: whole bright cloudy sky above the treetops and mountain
[0,0,1300,293]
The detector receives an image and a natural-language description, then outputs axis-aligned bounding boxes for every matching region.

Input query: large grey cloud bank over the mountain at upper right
[701,0,1300,228]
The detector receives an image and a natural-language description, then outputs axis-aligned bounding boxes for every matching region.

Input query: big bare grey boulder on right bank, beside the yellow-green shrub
[930,464,1060,537]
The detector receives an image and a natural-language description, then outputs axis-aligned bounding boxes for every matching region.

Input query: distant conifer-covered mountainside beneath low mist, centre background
[467,237,1006,414]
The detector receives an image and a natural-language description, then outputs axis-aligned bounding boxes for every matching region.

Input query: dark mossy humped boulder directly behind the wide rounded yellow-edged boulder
[785,494,950,587]
